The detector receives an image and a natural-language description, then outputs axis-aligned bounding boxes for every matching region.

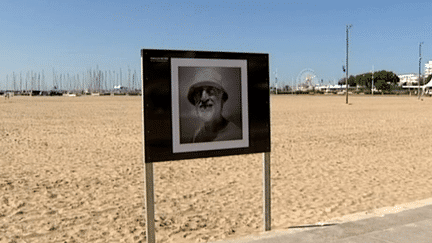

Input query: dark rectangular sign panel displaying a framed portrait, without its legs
[141,49,270,163]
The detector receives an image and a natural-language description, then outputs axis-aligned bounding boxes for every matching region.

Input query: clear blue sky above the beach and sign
[0,0,432,89]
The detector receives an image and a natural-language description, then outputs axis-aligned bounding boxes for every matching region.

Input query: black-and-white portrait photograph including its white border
[171,58,249,153]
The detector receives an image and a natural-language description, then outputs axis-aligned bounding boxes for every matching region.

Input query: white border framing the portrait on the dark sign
[171,58,249,153]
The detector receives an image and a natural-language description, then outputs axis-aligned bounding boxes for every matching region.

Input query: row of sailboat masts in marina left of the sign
[0,65,141,96]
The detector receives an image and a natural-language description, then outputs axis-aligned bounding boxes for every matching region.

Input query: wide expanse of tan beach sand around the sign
[0,95,432,243]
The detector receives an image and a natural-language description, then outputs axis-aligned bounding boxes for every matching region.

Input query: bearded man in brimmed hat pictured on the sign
[188,68,242,143]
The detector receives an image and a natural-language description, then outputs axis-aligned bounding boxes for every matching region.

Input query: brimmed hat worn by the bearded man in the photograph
[188,68,228,105]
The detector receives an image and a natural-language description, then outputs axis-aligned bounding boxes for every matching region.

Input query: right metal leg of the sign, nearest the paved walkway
[263,152,271,231]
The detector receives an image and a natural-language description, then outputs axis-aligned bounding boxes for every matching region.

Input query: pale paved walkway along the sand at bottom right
[212,202,432,243]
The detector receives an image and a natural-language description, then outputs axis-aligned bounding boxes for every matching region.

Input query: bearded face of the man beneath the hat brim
[194,86,223,122]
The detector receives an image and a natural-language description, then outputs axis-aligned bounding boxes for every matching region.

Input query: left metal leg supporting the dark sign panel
[144,163,156,243]
